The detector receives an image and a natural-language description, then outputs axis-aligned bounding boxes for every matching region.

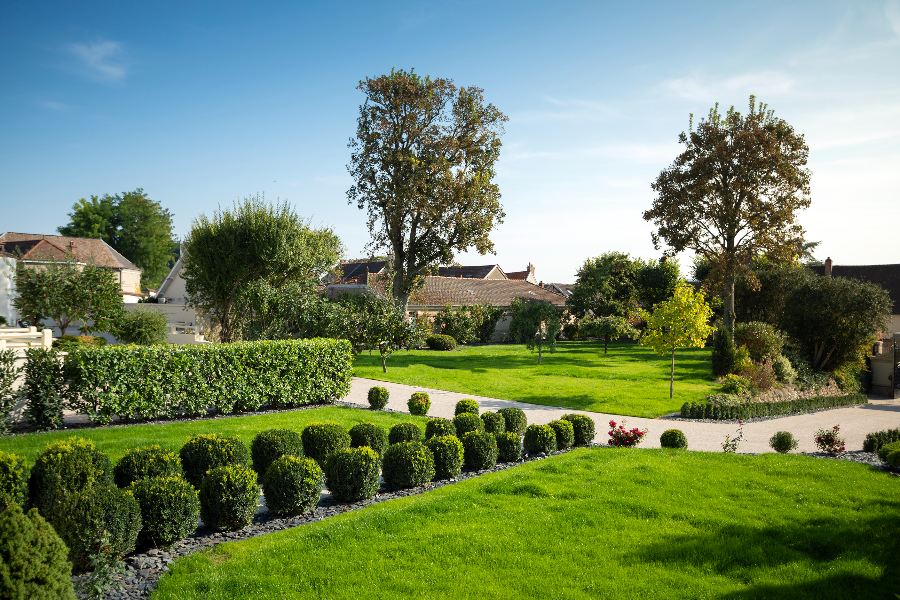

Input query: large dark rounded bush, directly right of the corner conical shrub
[54,485,141,569]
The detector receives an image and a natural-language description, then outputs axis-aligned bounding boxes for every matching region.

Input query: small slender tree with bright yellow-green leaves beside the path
[641,283,713,398]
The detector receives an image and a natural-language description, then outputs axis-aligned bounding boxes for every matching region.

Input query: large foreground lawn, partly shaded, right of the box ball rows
[153,449,900,600]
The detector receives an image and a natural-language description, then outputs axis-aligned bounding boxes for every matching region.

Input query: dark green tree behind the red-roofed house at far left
[57,188,178,287]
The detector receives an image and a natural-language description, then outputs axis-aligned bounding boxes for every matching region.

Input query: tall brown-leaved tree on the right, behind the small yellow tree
[644,96,810,331]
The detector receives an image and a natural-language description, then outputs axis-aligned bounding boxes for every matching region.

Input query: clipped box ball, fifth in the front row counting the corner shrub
[263,454,326,516]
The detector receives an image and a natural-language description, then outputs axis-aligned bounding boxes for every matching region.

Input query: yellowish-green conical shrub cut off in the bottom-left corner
[0,503,75,600]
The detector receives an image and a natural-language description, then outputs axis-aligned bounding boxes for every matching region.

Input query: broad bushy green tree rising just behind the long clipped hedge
[182,196,342,342]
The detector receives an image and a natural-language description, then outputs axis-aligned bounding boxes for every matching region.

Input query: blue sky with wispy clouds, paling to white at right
[0,0,900,283]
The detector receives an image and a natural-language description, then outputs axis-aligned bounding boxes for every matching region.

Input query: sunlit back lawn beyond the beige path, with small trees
[353,342,719,417]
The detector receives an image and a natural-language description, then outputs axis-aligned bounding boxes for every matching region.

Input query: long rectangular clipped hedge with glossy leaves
[65,339,352,423]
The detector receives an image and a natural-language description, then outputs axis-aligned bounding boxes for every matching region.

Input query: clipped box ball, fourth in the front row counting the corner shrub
[200,464,259,531]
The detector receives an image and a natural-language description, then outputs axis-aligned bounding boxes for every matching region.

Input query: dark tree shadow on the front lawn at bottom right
[626,501,900,600]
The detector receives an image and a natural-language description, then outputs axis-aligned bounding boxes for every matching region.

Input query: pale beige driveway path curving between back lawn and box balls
[344,377,900,453]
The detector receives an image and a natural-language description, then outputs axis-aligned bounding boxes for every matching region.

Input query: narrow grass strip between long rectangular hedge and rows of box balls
[0,406,427,464]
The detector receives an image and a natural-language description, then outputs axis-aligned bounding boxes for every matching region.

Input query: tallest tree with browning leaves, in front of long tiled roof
[347,70,507,313]
